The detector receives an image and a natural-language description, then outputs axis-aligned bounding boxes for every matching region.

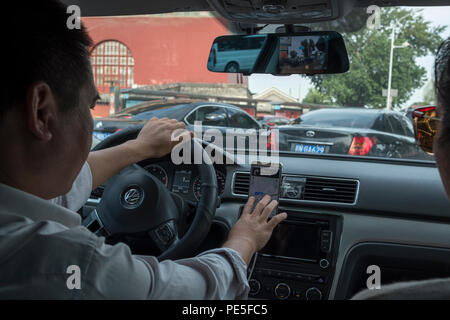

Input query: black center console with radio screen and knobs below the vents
[249,211,342,300]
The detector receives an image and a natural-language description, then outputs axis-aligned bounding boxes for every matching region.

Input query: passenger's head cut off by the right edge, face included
[433,38,450,198]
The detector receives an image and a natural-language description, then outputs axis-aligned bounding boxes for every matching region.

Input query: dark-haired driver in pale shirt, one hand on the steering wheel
[0,0,286,299]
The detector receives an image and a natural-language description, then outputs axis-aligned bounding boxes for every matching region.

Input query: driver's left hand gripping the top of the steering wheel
[134,117,192,159]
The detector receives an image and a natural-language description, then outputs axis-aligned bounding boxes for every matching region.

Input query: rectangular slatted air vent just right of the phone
[303,177,358,203]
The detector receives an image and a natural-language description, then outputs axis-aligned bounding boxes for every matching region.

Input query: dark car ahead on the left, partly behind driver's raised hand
[94,102,261,145]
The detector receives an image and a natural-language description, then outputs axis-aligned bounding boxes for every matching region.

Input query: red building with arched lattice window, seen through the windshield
[82,12,247,116]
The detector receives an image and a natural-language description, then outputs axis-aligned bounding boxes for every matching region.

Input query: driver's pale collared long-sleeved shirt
[0,162,249,299]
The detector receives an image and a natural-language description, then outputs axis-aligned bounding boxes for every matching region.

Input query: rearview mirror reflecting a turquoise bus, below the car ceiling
[207,31,349,75]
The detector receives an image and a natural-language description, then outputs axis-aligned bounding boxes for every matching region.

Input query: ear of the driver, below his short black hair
[24,81,58,141]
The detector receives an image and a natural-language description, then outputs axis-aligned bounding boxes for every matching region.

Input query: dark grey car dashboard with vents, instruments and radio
[85,148,450,300]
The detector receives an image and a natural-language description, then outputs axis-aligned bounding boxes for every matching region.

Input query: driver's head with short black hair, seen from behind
[0,0,97,198]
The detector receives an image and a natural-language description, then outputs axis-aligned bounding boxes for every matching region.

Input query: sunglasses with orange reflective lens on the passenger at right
[411,106,441,155]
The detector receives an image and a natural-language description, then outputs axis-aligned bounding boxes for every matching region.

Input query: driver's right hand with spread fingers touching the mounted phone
[223,195,287,265]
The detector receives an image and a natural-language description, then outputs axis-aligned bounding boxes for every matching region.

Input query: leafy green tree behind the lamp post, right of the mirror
[311,8,446,108]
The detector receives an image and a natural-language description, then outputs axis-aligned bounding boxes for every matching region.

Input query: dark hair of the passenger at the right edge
[434,38,450,143]
